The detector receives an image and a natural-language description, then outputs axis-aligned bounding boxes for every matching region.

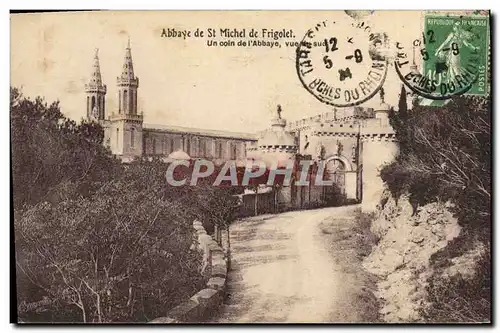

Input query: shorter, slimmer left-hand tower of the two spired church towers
[85,49,106,121]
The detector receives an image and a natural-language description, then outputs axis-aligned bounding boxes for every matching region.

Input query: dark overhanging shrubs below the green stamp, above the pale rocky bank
[381,96,491,238]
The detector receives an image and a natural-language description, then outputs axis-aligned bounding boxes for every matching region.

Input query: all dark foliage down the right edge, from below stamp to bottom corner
[381,92,491,322]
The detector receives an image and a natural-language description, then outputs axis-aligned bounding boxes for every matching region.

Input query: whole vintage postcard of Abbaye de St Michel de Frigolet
[10,10,492,325]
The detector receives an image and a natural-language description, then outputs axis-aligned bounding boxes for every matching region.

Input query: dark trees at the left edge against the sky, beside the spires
[10,88,119,209]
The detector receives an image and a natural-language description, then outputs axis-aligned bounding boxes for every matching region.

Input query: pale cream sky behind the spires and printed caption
[11,11,423,133]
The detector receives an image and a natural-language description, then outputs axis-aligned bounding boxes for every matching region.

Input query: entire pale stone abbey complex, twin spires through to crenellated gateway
[85,42,398,210]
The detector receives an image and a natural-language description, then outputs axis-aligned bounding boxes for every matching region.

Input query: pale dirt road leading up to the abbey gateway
[209,206,376,323]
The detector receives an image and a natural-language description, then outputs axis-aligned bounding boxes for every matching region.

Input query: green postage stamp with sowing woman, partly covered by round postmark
[420,14,490,97]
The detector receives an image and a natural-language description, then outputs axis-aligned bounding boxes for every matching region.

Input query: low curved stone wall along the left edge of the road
[150,221,228,324]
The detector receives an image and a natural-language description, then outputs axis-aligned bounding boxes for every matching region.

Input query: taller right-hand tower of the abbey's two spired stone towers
[109,39,143,158]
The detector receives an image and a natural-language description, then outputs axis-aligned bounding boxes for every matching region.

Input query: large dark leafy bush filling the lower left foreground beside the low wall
[15,180,203,322]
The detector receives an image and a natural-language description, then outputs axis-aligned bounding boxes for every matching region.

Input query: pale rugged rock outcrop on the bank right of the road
[363,191,461,322]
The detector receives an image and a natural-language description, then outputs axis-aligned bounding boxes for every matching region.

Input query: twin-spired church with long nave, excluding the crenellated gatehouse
[85,41,257,162]
